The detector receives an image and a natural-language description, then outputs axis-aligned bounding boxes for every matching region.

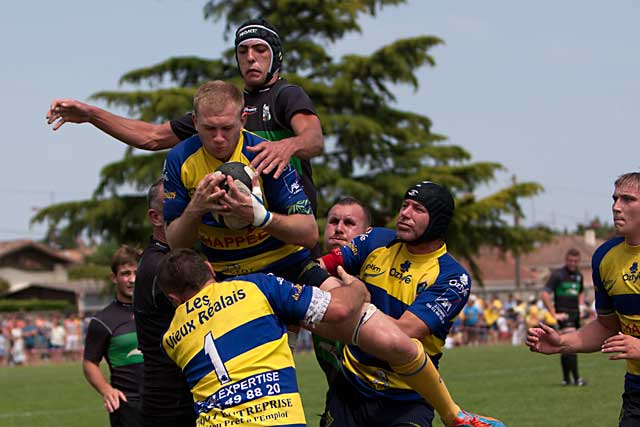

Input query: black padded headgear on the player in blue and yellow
[404,181,455,242]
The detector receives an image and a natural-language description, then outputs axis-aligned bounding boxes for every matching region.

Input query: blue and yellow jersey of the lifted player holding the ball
[163,130,312,276]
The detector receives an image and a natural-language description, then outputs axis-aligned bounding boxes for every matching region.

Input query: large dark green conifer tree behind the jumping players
[34,0,548,284]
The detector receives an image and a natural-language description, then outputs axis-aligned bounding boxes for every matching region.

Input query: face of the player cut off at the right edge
[613,184,640,245]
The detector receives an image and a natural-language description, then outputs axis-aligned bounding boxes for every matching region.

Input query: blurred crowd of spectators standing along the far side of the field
[0,294,594,366]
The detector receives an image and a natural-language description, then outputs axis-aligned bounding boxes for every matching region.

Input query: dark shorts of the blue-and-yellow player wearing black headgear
[320,375,434,427]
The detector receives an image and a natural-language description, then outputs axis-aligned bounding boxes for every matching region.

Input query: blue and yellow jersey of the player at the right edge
[591,237,640,391]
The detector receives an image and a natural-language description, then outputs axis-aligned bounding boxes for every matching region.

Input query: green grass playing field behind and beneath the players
[0,346,625,427]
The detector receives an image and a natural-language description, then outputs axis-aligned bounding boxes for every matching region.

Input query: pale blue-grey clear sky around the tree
[0,0,640,240]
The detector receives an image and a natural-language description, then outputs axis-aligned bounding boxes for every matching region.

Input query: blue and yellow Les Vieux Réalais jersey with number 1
[162,274,326,427]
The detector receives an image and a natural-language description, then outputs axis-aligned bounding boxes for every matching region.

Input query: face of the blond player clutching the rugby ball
[194,103,245,162]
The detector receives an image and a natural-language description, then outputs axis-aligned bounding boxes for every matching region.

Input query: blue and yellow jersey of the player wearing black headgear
[340,228,471,400]
